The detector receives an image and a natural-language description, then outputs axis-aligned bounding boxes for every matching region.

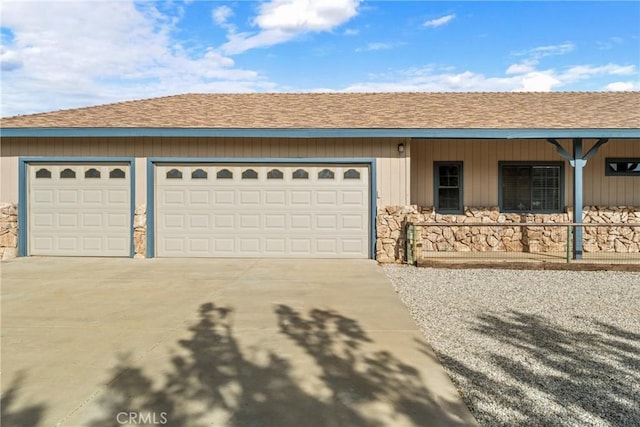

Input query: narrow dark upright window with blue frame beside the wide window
[433,162,463,214]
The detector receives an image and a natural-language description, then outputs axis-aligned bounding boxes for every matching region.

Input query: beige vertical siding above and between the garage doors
[0,137,410,206]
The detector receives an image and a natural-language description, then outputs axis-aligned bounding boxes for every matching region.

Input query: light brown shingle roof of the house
[1,92,640,129]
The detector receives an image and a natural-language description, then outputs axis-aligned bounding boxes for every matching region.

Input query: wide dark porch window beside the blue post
[499,162,564,212]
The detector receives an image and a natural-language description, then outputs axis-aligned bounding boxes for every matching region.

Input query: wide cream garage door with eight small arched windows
[156,164,370,258]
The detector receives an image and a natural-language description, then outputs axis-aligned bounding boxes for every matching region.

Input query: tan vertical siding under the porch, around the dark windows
[411,139,640,207]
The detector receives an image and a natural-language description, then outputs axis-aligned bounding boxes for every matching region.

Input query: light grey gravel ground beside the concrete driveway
[384,265,640,427]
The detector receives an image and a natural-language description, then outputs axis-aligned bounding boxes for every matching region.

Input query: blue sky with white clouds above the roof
[0,0,640,117]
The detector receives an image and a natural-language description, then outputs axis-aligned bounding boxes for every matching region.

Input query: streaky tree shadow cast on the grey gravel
[438,311,640,426]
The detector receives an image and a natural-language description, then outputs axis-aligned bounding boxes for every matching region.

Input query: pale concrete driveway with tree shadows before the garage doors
[0,258,475,427]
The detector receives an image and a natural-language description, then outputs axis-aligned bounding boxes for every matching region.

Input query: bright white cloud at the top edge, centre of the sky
[220,0,361,55]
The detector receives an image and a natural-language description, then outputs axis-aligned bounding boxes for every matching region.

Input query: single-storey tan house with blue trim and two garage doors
[0,92,640,262]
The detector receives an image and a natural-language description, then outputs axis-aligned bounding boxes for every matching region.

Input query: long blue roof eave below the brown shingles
[0,127,640,139]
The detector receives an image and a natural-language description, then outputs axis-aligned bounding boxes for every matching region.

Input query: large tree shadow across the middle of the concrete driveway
[88,303,463,427]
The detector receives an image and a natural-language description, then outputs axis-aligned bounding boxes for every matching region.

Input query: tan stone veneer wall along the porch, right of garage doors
[376,206,640,263]
